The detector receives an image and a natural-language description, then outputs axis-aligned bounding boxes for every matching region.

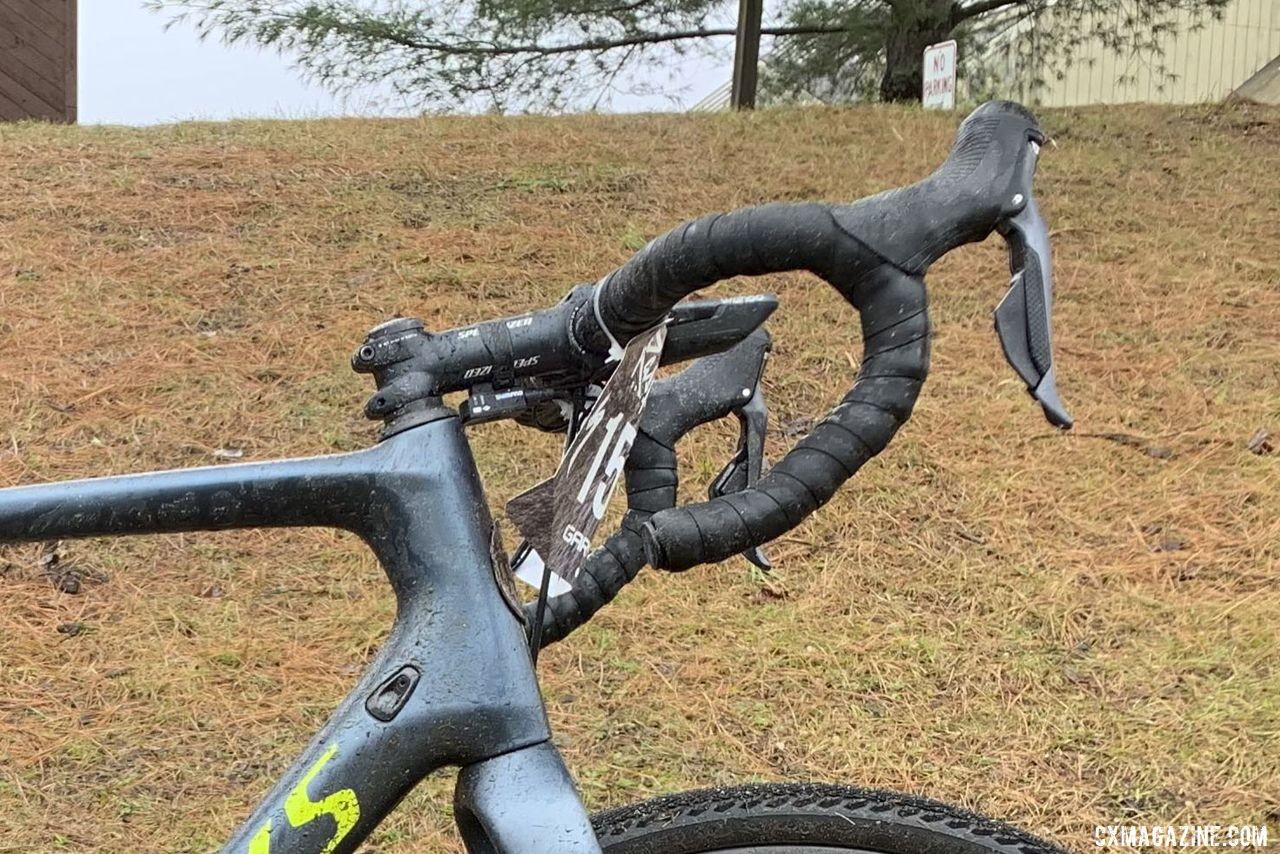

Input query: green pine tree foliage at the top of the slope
[150,0,1230,111]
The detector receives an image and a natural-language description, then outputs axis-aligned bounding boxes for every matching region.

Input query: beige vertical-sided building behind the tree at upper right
[984,0,1280,106]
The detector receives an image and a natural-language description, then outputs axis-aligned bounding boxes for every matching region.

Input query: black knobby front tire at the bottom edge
[591,784,1064,854]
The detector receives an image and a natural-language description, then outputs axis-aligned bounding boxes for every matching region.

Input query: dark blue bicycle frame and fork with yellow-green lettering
[0,416,600,854]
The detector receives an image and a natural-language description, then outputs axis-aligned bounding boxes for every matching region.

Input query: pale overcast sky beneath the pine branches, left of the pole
[79,0,731,124]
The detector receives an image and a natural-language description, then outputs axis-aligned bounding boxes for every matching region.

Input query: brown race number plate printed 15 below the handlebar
[507,324,667,586]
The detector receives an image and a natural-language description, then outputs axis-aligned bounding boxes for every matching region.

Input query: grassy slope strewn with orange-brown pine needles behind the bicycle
[0,108,1280,851]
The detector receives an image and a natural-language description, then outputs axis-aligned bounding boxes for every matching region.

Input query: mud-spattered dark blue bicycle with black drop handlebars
[0,102,1070,854]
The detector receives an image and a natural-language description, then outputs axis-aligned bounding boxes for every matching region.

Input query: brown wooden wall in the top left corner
[0,0,76,122]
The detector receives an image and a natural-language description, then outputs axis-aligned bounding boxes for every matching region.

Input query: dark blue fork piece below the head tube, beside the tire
[453,741,600,854]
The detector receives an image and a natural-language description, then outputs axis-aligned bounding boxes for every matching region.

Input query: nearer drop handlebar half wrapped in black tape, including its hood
[563,102,1044,570]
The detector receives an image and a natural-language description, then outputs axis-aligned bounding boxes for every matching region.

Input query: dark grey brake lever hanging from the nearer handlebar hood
[996,141,1071,429]
